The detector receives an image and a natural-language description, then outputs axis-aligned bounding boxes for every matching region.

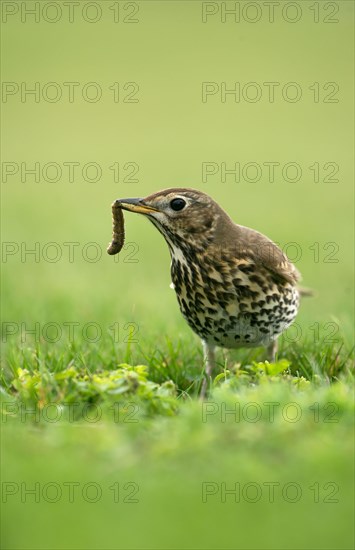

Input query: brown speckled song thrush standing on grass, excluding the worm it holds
[115,188,300,395]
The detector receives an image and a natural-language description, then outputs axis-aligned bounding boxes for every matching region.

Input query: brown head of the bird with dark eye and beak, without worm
[116,188,229,252]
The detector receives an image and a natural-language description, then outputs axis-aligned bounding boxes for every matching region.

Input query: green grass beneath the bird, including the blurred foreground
[1,337,354,549]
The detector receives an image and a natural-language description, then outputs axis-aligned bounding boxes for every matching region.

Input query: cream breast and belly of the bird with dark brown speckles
[171,254,299,348]
